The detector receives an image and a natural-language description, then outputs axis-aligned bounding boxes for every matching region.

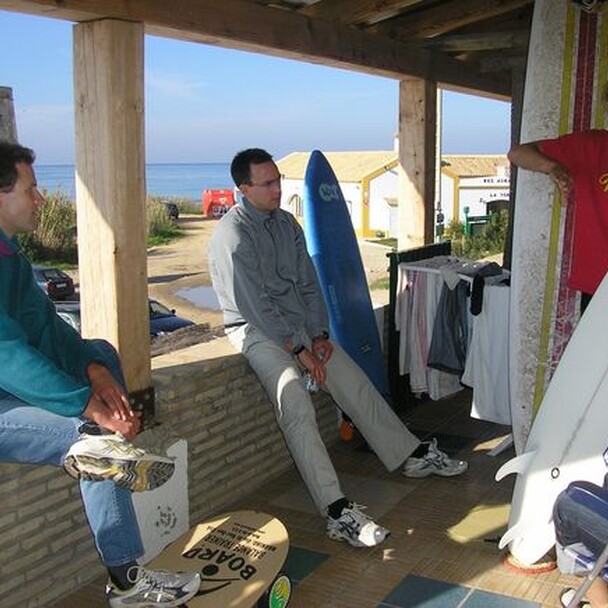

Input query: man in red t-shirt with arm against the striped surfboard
[508,130,608,295]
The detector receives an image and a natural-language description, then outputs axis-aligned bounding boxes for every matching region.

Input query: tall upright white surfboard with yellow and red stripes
[509,0,608,454]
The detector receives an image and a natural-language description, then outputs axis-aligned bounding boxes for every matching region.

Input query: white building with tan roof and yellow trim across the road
[277,150,509,238]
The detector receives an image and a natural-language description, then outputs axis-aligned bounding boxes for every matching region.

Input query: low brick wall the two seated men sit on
[0,338,338,608]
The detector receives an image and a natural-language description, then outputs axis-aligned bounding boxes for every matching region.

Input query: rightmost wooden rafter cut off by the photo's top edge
[370,0,533,41]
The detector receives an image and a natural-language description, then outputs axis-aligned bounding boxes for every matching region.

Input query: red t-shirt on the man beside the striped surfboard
[540,130,608,293]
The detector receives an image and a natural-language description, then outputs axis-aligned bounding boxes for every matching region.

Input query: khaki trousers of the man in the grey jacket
[228,324,420,515]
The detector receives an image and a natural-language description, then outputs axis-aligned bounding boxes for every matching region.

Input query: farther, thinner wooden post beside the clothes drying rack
[397,78,437,251]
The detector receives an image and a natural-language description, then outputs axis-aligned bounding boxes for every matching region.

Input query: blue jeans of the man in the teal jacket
[0,340,144,566]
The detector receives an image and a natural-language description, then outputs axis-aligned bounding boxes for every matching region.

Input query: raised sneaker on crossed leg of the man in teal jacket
[63,433,175,492]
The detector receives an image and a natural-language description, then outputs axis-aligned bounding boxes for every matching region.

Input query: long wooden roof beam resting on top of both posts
[0,0,510,98]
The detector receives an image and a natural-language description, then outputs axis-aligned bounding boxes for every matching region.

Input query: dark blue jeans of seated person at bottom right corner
[553,484,608,575]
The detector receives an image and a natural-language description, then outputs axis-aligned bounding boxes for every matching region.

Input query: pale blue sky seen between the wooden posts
[0,11,510,164]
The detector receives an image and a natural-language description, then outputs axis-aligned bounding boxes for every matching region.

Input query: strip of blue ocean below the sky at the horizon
[34,163,233,201]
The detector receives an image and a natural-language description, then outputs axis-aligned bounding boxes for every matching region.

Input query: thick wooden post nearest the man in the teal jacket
[74,20,151,391]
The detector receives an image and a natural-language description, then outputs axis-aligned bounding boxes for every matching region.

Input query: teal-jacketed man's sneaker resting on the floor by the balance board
[106,566,201,608]
